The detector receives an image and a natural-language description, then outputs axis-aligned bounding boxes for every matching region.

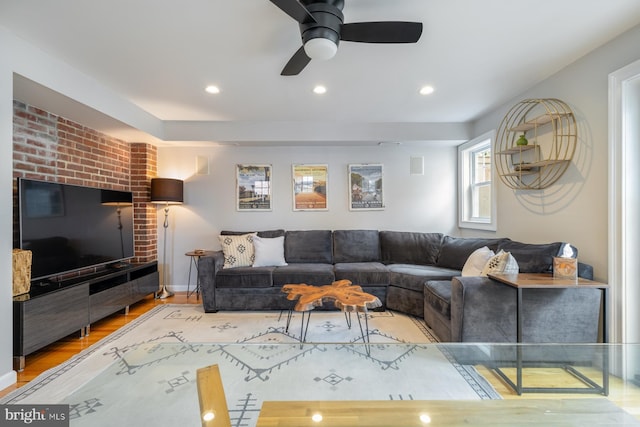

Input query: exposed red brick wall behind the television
[13,101,157,262]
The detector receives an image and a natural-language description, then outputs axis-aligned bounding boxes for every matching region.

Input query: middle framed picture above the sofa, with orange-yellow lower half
[292,164,329,211]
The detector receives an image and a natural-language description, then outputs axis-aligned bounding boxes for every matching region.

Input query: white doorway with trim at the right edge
[608,61,640,376]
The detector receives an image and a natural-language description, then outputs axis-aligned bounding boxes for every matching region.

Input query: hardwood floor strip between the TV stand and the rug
[0,292,201,397]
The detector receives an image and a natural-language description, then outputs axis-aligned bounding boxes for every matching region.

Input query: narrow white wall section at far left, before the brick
[0,28,16,390]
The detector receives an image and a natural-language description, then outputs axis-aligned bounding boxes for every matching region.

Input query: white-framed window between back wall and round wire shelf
[458,131,496,231]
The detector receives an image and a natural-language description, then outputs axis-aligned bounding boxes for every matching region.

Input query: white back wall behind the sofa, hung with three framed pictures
[158,144,457,290]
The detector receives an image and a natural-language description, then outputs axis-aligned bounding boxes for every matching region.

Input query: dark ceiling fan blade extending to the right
[340,21,422,43]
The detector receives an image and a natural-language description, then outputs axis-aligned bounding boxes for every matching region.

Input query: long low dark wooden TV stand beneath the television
[13,261,159,371]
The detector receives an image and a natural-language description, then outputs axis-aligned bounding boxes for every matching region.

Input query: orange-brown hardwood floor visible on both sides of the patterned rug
[0,292,640,419]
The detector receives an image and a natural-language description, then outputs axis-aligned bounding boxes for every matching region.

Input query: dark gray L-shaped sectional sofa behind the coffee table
[198,230,601,342]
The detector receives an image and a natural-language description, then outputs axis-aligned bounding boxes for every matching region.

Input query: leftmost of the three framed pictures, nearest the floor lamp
[236,165,271,211]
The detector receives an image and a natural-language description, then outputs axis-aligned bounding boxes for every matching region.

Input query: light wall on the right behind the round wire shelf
[473,27,640,281]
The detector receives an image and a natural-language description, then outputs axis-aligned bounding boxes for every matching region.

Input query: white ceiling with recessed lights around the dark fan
[0,0,640,145]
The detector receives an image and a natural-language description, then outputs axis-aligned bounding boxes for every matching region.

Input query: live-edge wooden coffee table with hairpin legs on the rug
[282,280,382,343]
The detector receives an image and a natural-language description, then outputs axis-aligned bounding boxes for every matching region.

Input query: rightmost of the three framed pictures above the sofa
[349,164,384,211]
